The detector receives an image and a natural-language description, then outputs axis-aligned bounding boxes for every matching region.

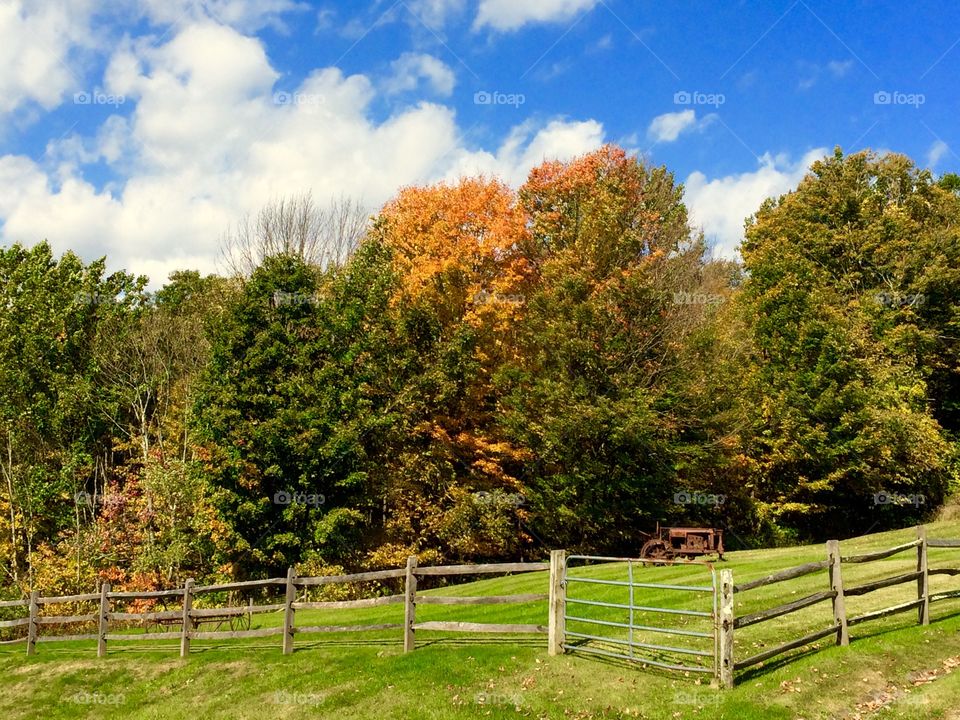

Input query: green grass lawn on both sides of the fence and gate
[0,522,960,720]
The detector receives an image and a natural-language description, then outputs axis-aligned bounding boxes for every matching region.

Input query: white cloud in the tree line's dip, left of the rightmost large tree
[684,148,827,257]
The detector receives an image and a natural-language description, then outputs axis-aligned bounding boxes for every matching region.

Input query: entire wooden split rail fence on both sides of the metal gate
[7,527,960,688]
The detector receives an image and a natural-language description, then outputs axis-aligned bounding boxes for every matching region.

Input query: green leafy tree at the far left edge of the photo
[0,243,144,583]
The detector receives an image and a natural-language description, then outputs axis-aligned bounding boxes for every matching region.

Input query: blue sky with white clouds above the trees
[0,0,960,285]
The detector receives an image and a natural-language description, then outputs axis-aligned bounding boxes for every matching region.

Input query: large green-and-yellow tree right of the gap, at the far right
[740,150,960,536]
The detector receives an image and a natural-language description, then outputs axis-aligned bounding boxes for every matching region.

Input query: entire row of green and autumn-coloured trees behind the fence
[0,146,960,595]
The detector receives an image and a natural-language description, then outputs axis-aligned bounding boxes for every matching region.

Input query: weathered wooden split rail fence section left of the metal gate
[0,557,559,657]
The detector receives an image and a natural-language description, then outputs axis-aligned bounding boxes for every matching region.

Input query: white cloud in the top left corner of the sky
[0,0,94,114]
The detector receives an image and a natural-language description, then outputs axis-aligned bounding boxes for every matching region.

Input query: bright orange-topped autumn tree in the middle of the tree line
[374,178,532,557]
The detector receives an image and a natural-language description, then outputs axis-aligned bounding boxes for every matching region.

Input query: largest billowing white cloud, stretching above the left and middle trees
[0,23,603,286]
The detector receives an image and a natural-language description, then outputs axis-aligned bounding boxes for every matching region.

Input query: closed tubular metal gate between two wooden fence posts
[563,555,719,677]
